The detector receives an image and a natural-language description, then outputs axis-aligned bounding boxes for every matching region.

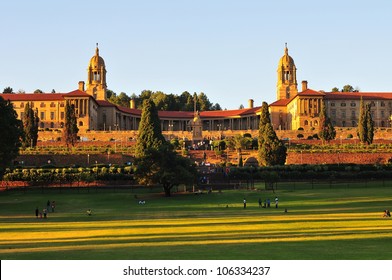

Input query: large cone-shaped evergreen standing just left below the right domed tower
[258,102,287,166]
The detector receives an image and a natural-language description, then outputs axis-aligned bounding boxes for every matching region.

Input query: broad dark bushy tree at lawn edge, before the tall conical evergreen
[134,143,196,197]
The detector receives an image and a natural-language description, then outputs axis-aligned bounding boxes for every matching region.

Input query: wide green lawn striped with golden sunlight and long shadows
[0,184,392,260]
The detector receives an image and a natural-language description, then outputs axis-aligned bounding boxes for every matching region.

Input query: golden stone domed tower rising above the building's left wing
[86,43,107,100]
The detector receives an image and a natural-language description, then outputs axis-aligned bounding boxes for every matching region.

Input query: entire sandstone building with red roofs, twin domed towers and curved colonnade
[1,46,392,140]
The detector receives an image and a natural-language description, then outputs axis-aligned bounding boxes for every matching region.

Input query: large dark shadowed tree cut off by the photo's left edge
[0,96,23,178]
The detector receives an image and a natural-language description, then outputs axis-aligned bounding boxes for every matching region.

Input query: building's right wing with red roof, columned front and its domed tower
[270,45,392,131]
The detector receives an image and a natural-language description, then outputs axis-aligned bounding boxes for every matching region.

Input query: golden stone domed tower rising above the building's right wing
[276,43,298,100]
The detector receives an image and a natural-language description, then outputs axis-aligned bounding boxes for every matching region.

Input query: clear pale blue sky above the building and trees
[0,0,392,109]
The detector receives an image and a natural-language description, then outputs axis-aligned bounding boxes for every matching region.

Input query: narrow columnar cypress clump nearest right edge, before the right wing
[357,97,374,145]
